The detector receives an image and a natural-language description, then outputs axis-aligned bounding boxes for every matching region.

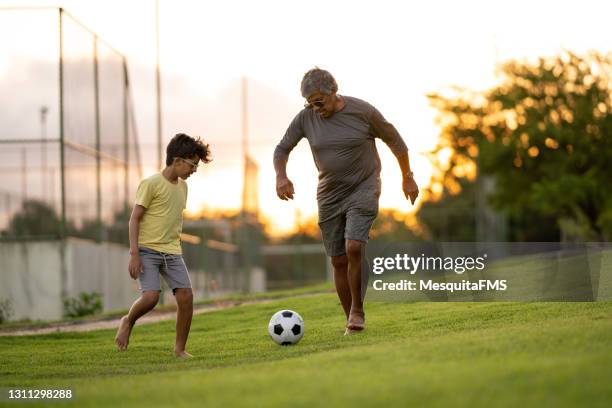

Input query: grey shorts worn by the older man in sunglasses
[319,188,380,256]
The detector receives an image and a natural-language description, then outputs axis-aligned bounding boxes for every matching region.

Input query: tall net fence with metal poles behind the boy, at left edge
[0,8,142,243]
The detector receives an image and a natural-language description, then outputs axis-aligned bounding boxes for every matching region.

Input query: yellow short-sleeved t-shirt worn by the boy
[136,173,187,255]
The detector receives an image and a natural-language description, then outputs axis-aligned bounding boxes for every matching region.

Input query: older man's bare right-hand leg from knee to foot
[346,239,365,330]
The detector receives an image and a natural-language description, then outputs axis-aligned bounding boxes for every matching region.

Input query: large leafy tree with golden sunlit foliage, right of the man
[429,52,612,240]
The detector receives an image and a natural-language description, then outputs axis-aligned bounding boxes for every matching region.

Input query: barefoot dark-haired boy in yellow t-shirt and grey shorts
[115,133,211,357]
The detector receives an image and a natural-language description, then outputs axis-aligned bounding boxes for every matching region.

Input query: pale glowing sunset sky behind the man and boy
[0,0,612,232]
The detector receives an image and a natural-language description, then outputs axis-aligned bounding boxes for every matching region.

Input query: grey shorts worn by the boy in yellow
[138,247,191,293]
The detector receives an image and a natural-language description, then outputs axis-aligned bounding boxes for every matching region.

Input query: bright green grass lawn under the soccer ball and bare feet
[0,294,612,407]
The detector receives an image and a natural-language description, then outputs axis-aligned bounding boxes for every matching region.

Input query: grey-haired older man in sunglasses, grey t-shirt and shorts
[274,68,419,334]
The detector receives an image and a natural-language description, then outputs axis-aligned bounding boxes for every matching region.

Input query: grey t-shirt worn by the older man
[274,96,408,222]
